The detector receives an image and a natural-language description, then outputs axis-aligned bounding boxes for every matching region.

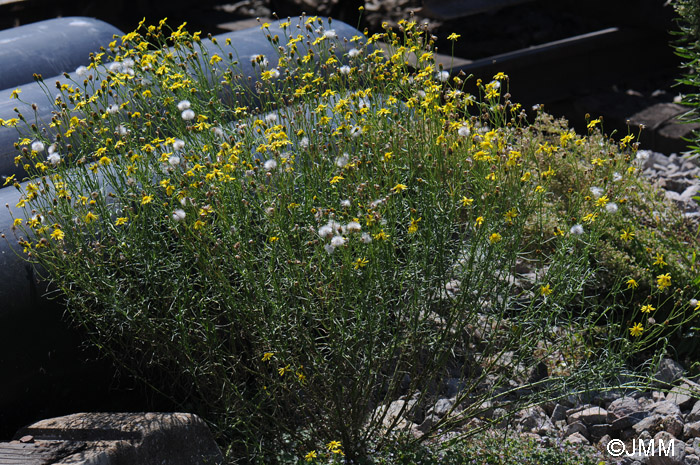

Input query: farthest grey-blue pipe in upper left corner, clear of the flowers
[0,16,124,89]
